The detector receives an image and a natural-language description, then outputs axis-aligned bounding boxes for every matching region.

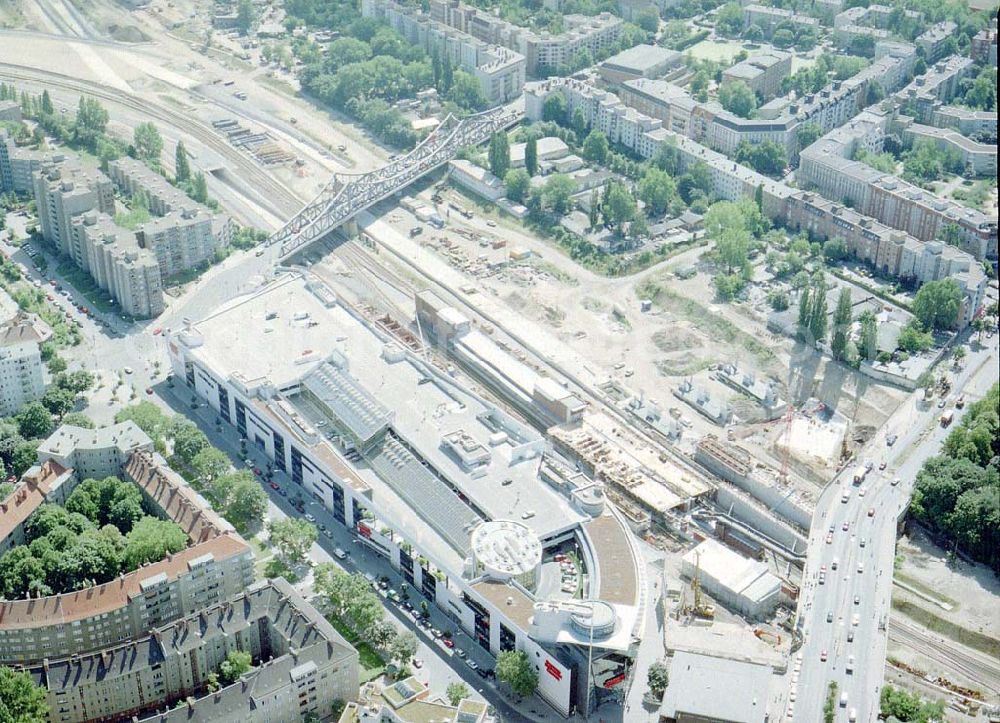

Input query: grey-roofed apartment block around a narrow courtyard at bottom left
[28,578,358,723]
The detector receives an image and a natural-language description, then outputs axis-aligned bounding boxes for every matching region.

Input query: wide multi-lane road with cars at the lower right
[785,341,997,723]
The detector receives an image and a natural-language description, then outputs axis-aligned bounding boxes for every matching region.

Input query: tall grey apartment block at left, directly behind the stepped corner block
[33,160,115,271]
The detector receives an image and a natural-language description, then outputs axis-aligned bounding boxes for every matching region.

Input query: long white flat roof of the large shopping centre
[182,276,585,551]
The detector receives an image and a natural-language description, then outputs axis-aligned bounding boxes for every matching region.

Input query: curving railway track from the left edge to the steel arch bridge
[0,63,304,218]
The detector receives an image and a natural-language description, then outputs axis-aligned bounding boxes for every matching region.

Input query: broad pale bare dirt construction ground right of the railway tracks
[387,188,905,504]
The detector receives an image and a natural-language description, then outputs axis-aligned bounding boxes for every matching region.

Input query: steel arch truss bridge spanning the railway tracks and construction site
[267,106,523,261]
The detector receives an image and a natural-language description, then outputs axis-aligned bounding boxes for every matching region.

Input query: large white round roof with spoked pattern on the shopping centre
[472,520,542,590]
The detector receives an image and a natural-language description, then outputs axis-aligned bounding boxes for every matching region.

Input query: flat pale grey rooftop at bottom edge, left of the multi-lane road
[660,652,771,723]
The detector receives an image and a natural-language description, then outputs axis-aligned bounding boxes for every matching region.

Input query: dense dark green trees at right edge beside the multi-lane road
[903,384,1000,576]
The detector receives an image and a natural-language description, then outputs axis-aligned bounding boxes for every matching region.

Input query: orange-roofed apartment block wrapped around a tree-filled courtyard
[0,436,254,665]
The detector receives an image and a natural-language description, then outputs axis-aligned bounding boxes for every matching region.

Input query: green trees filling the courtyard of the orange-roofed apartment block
[0,477,187,599]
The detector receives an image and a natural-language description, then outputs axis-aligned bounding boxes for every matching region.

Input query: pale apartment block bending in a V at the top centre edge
[430,0,624,75]
